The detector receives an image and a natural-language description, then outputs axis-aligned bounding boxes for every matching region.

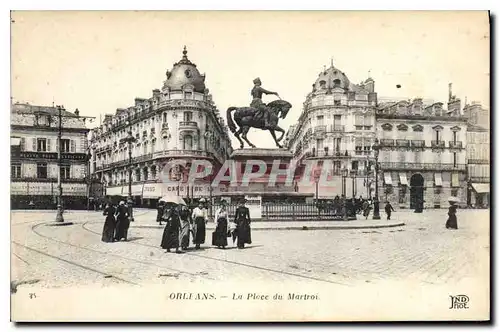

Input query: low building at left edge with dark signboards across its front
[11,103,89,209]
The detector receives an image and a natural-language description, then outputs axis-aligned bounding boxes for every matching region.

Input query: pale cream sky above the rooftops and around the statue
[11,11,490,148]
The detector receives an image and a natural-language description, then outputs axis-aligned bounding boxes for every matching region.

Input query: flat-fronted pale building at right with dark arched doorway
[376,96,467,209]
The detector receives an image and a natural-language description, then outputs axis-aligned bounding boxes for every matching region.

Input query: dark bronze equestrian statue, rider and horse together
[226,78,292,149]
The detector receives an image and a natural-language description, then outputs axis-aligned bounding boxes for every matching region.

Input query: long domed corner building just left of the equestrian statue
[91,48,232,206]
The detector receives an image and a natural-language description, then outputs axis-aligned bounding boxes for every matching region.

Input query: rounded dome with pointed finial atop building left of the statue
[163,46,205,93]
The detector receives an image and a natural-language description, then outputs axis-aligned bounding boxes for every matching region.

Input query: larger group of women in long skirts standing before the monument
[157,199,252,253]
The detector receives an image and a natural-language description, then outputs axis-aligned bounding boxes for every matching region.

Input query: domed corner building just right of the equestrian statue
[285,64,377,198]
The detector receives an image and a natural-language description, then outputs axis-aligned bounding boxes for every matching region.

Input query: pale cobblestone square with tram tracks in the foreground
[11,209,490,287]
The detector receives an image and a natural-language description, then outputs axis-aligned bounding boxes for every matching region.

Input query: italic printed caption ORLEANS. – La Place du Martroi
[168,292,319,301]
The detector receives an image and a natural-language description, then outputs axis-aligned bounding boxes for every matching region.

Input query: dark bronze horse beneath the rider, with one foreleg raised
[226,100,292,149]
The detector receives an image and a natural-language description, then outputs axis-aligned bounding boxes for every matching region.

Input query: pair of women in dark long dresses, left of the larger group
[101,201,130,242]
